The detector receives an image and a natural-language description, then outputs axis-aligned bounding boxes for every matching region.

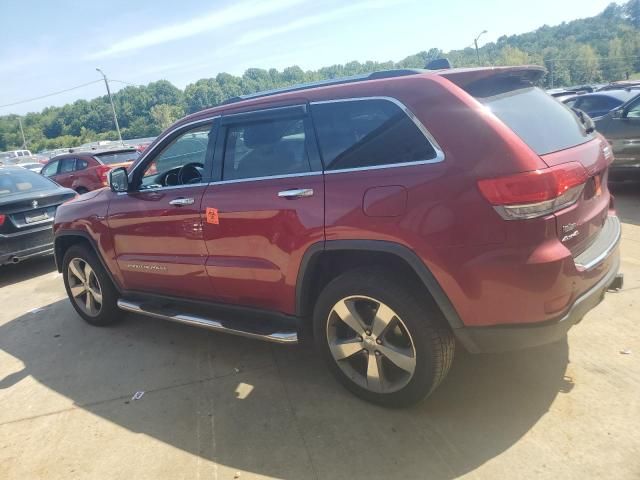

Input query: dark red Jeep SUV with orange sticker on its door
[55,67,622,406]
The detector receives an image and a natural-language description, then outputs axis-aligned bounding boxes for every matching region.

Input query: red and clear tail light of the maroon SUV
[478,162,589,220]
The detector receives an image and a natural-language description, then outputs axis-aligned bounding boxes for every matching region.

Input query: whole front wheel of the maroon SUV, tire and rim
[63,245,120,326]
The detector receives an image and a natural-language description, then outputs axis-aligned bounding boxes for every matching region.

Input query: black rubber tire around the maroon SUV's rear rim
[313,268,455,407]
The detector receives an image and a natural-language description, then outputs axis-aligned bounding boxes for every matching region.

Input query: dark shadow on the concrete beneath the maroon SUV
[0,300,572,479]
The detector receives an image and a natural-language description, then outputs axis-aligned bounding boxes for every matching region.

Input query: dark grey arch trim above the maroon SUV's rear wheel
[296,240,464,330]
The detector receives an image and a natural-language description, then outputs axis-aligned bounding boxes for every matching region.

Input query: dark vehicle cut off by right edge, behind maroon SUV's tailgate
[595,91,640,180]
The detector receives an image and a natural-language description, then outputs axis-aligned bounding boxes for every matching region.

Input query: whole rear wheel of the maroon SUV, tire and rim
[314,268,455,407]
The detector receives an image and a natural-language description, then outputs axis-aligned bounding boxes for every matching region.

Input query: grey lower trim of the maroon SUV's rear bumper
[454,251,620,353]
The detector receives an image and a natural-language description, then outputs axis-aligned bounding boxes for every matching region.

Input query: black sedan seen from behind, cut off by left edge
[0,167,77,265]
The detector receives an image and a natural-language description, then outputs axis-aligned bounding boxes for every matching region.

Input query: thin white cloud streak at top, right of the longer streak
[234,0,405,45]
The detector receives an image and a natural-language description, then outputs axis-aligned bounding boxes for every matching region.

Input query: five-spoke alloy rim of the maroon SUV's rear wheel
[326,296,416,393]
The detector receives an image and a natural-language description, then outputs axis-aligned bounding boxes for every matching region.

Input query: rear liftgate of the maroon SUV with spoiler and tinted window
[444,67,613,257]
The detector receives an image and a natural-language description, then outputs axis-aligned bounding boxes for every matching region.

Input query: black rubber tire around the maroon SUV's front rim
[62,244,122,327]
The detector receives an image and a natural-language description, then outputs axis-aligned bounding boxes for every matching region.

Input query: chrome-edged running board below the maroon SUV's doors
[118,299,298,345]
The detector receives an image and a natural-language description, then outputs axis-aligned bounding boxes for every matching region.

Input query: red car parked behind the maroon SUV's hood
[40,148,140,194]
